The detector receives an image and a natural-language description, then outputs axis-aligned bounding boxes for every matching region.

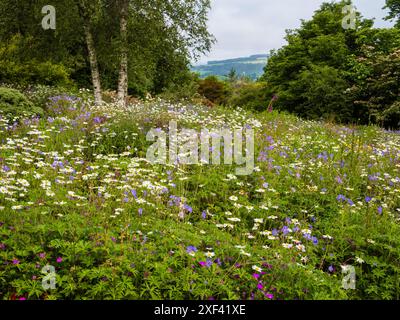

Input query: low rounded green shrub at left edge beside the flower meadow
[0,88,43,117]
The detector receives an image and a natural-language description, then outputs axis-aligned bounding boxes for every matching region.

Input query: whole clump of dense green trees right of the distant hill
[263,1,400,128]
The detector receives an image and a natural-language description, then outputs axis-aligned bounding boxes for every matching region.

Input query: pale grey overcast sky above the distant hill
[200,0,392,63]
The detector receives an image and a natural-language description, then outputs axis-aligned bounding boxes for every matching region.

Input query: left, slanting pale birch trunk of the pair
[77,0,103,105]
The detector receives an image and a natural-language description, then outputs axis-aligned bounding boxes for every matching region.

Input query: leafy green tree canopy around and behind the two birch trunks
[0,0,214,97]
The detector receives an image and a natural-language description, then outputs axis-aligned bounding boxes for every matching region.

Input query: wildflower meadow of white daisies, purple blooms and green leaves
[0,90,400,300]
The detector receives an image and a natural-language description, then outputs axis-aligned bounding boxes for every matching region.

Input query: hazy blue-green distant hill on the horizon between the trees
[191,54,269,80]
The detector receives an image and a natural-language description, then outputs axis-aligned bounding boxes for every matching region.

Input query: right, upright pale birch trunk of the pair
[118,0,129,106]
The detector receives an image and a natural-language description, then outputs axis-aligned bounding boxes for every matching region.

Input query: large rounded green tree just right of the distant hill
[263,2,353,121]
